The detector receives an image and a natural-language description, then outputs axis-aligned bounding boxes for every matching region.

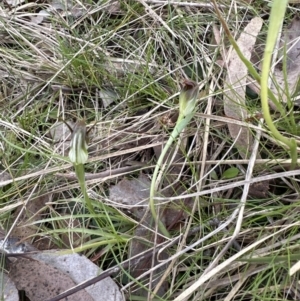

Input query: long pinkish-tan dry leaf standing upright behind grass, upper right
[224,17,262,158]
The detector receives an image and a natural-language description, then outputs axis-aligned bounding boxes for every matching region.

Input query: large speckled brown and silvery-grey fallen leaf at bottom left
[9,251,124,301]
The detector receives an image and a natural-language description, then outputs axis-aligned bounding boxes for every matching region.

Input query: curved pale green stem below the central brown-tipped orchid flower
[149,113,194,237]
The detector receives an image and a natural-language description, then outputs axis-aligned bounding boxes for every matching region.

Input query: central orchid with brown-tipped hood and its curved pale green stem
[149,80,199,237]
